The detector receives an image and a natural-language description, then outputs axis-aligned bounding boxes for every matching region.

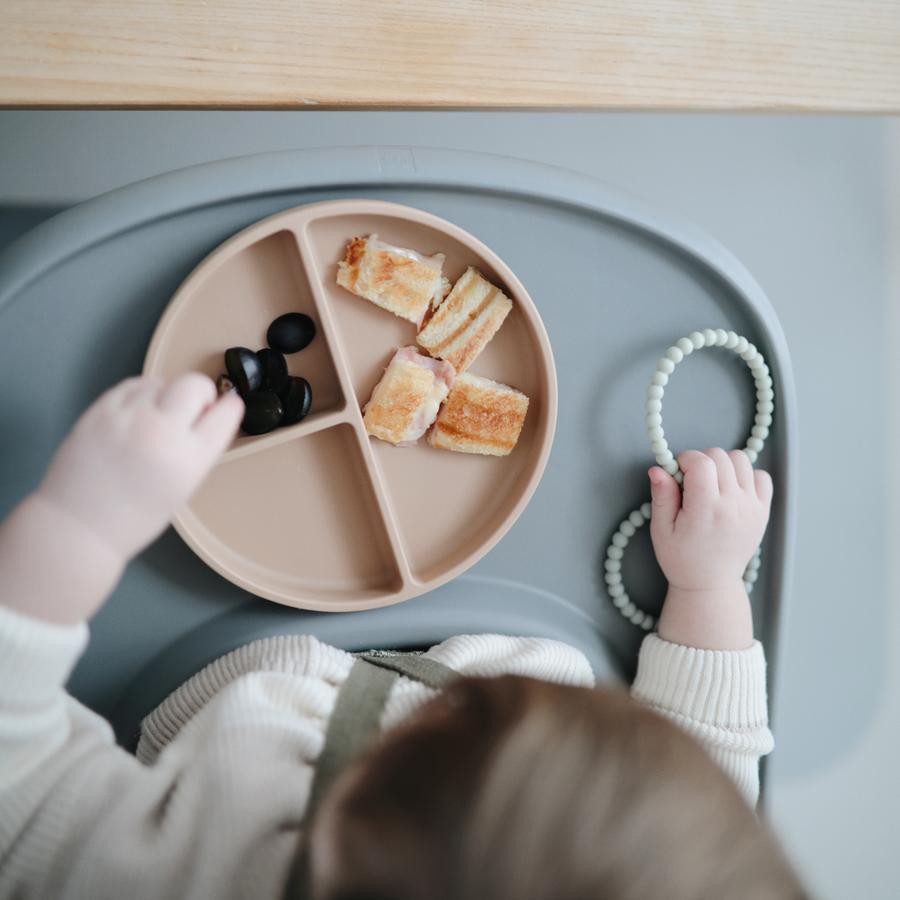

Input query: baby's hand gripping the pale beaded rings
[649,447,772,591]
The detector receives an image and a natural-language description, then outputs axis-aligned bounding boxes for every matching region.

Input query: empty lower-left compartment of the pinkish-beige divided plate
[177,425,402,610]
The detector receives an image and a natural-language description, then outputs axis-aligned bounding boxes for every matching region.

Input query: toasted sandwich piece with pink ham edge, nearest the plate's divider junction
[363,347,456,445]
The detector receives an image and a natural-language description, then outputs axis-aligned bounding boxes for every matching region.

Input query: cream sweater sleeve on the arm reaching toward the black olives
[0,607,316,900]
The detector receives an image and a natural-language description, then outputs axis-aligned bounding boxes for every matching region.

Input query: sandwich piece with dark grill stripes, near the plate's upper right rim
[416,268,512,372]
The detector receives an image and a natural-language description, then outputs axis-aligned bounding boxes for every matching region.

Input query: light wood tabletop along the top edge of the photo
[0,0,900,112]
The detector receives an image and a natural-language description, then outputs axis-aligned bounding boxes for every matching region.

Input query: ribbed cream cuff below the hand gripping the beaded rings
[632,635,768,729]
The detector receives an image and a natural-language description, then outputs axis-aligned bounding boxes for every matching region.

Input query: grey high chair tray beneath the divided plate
[0,147,797,756]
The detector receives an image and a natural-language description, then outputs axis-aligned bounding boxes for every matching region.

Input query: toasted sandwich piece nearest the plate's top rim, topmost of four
[337,234,450,325]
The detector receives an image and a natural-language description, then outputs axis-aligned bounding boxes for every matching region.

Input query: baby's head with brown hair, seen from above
[310,676,806,900]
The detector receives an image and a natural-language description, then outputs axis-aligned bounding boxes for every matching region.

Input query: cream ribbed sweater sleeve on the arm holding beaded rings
[631,635,773,806]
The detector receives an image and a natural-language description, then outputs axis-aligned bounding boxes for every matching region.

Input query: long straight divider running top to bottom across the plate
[292,225,416,593]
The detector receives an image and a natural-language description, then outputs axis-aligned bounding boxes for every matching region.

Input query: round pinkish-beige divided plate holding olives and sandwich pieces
[144,200,556,611]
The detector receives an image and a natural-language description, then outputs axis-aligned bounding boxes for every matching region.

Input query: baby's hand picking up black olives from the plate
[38,374,244,561]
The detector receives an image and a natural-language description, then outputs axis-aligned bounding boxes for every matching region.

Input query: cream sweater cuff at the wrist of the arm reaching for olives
[0,606,88,705]
